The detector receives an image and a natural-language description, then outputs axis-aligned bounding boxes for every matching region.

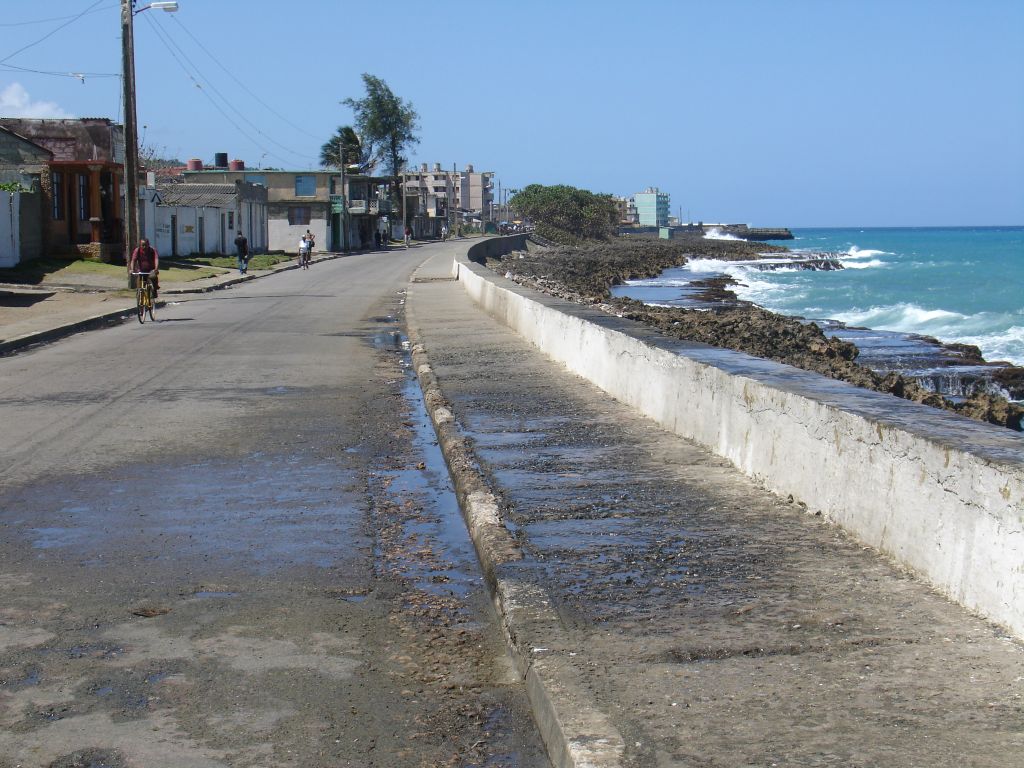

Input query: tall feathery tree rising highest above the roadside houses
[342,73,420,176]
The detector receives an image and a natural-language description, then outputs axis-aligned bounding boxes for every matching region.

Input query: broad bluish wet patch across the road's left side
[0,454,372,577]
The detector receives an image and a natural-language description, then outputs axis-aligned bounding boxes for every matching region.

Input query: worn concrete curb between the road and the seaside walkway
[406,273,625,768]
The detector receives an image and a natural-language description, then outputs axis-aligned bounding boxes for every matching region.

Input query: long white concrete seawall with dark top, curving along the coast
[454,239,1024,638]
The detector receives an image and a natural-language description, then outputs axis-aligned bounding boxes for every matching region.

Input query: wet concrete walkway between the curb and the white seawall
[410,249,1024,767]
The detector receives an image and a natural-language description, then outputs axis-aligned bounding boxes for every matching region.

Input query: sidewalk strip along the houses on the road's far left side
[0,253,343,355]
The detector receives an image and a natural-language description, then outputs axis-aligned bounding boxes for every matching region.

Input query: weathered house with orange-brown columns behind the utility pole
[0,118,125,261]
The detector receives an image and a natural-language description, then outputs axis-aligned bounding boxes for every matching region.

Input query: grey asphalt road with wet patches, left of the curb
[0,246,547,768]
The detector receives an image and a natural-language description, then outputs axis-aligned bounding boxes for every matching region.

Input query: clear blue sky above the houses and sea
[0,0,1024,227]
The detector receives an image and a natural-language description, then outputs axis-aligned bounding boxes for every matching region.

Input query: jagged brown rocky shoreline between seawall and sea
[490,237,1024,431]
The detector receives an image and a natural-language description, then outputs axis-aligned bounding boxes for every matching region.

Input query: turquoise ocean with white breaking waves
[614,226,1024,366]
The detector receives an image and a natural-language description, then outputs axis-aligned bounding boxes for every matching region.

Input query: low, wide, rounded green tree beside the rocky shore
[509,184,618,241]
